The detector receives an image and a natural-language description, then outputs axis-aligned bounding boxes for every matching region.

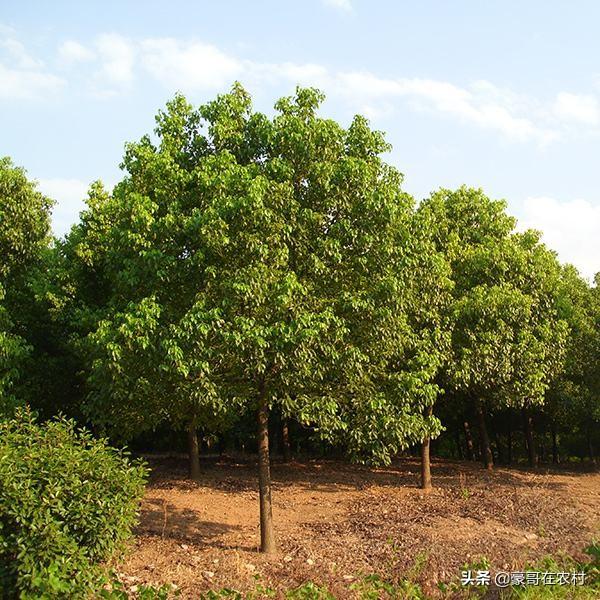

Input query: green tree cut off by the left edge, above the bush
[0,157,52,412]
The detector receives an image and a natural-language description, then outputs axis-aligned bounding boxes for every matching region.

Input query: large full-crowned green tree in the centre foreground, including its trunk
[73,85,446,552]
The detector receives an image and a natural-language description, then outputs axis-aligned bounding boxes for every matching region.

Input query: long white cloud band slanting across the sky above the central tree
[41,32,600,146]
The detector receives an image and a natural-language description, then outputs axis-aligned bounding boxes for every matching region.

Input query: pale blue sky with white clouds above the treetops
[0,0,600,277]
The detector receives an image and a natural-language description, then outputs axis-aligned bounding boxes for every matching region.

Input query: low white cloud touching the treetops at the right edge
[519,197,600,280]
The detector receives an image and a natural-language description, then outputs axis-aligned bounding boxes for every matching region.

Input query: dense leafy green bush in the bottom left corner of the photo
[0,411,147,598]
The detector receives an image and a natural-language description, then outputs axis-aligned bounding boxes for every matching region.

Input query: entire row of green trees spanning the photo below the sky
[0,84,600,552]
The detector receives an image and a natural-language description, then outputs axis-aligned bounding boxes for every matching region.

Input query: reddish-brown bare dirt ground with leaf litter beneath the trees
[119,458,600,598]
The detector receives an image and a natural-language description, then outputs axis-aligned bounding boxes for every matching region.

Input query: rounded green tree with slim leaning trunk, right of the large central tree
[420,187,566,469]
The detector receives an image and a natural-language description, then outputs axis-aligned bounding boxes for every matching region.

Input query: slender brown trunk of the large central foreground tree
[258,383,277,554]
